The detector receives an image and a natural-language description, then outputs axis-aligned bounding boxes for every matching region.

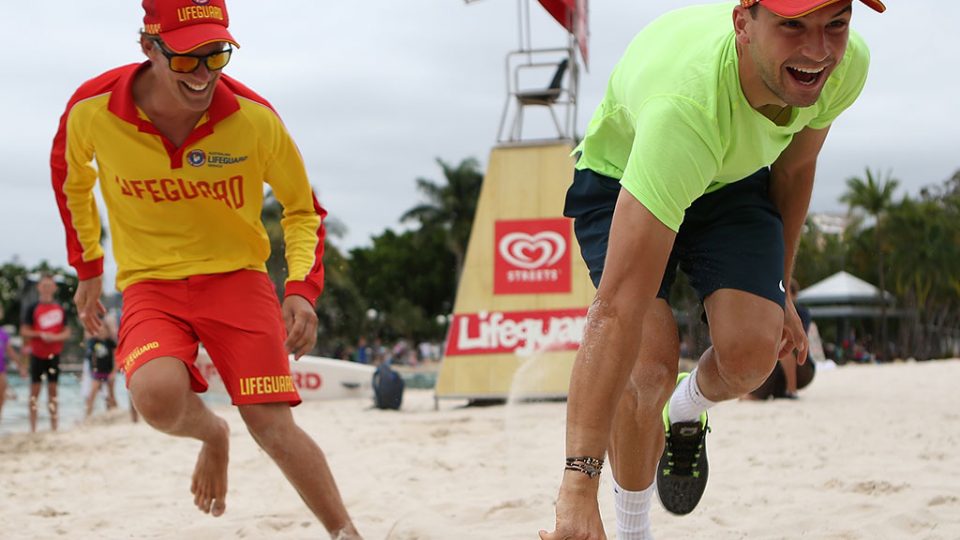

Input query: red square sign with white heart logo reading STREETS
[494,218,570,294]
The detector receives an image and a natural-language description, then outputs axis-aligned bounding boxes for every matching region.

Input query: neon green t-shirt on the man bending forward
[575,3,870,231]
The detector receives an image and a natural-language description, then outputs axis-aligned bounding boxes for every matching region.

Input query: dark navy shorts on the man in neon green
[563,168,786,307]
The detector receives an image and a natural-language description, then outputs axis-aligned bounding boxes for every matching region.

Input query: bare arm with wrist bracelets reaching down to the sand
[540,190,676,540]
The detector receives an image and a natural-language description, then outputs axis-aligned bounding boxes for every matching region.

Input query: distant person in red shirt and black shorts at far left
[20,274,70,432]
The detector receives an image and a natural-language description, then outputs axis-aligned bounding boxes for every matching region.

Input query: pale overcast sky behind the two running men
[0,0,960,292]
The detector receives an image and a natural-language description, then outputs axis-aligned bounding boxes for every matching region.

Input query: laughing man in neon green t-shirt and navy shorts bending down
[540,0,884,540]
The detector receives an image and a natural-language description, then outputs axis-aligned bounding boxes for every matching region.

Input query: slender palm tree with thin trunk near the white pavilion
[840,167,900,360]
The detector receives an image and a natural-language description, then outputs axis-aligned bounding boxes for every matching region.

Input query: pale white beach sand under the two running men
[0,360,960,540]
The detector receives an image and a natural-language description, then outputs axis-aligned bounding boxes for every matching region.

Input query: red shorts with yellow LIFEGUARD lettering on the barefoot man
[117,270,300,406]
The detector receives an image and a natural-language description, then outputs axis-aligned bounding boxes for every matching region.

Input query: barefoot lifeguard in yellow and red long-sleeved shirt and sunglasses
[51,0,359,539]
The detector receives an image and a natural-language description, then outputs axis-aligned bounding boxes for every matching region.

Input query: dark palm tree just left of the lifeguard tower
[400,158,483,283]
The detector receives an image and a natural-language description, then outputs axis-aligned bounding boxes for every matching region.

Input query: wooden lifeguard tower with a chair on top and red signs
[436,0,594,399]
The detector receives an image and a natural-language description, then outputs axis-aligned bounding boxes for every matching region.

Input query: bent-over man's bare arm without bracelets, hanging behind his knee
[770,127,830,364]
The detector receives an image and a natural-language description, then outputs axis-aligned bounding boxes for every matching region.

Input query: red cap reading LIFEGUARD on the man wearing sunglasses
[143,0,240,53]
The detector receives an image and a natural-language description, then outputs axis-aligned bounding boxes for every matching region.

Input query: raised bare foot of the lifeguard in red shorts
[190,418,230,517]
